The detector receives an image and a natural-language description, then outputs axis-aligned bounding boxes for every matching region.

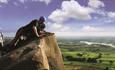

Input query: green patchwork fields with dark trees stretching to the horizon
[58,38,115,70]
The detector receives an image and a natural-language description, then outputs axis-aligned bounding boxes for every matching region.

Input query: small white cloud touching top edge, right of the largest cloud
[88,0,105,9]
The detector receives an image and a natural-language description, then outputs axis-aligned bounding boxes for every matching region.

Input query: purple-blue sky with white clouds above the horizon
[0,0,115,36]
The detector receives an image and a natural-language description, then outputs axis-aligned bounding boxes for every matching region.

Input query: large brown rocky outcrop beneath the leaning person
[0,35,64,70]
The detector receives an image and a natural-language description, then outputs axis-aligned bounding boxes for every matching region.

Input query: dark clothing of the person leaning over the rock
[11,19,45,46]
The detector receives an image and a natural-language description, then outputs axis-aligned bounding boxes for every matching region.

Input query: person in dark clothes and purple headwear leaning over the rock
[11,16,45,47]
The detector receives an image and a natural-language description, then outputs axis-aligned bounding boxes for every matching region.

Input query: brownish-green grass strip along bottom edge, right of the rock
[64,61,104,70]
